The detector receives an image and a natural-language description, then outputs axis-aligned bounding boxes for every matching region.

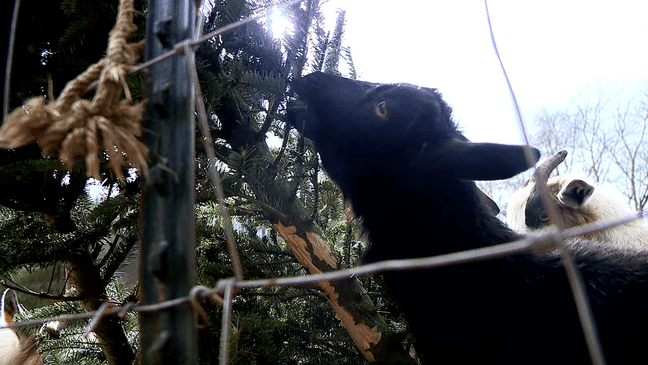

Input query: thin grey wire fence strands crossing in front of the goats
[0,0,648,365]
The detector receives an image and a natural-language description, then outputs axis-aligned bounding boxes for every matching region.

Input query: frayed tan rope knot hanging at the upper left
[0,0,148,182]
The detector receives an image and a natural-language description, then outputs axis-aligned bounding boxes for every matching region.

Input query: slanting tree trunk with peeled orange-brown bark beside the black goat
[211,64,415,364]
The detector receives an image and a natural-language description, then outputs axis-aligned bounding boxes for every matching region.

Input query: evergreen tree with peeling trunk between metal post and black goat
[192,1,411,363]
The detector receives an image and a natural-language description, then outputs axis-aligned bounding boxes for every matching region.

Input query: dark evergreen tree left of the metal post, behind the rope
[0,0,144,364]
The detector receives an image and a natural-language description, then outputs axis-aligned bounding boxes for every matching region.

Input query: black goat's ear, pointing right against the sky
[428,139,540,180]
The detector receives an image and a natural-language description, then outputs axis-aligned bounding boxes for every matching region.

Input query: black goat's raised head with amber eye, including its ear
[288,72,540,190]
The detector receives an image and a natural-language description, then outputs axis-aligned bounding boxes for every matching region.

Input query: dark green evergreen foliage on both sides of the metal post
[0,0,409,364]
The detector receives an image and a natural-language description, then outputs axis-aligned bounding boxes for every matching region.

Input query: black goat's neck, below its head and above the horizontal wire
[350,177,520,260]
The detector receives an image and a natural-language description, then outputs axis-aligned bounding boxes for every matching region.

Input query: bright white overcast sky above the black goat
[324,0,648,143]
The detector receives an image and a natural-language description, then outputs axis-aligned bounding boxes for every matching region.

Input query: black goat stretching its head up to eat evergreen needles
[288,73,648,364]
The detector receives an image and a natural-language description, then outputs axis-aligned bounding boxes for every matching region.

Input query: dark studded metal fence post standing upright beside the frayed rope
[140,0,198,364]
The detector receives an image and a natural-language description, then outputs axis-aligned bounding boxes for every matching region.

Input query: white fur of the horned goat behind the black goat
[507,175,648,249]
